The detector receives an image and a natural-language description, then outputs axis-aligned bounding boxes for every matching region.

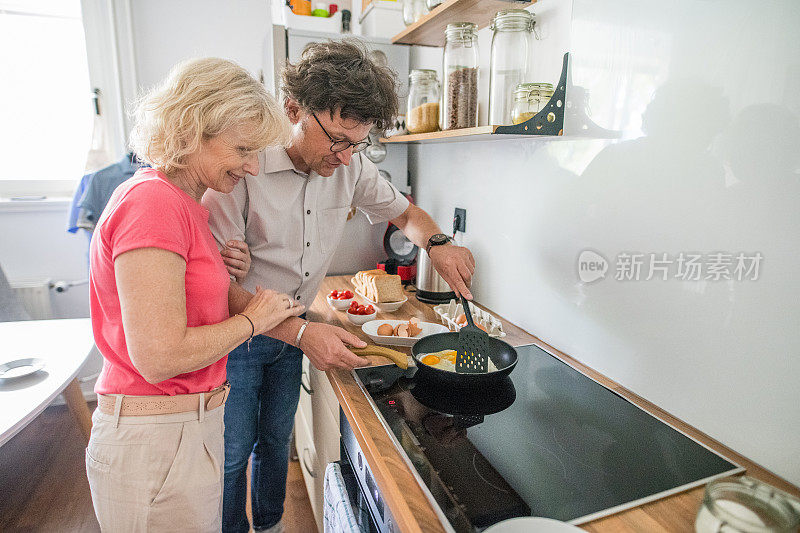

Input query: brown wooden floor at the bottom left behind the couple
[0,405,316,533]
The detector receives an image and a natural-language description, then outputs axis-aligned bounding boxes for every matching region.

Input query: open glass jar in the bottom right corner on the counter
[694,476,800,533]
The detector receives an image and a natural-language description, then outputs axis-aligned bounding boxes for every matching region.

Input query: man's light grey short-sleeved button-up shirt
[203,147,409,306]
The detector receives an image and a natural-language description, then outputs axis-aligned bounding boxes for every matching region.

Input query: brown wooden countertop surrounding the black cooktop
[308,276,800,533]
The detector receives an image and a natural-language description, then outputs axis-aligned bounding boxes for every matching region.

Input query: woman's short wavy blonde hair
[125,57,291,173]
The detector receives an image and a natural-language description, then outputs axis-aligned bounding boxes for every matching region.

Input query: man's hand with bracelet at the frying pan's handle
[300,322,369,372]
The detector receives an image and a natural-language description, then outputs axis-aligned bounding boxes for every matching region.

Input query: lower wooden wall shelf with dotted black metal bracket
[381,52,569,144]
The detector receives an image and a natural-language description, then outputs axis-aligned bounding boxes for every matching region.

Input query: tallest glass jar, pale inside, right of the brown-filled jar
[489,9,534,125]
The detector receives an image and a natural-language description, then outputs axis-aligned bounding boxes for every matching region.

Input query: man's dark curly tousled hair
[282,39,397,130]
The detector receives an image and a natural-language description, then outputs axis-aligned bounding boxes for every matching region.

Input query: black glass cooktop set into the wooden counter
[355,345,742,532]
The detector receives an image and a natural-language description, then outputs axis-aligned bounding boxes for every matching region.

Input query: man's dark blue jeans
[222,335,303,533]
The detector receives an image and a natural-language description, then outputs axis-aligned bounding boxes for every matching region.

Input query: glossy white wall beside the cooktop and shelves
[409,0,800,484]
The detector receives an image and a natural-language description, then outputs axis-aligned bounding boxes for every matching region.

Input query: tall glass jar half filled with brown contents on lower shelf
[440,22,478,130]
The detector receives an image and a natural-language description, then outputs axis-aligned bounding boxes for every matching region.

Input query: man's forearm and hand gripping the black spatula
[391,204,475,300]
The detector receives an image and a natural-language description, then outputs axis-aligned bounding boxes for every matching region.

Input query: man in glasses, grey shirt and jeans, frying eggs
[203,41,475,532]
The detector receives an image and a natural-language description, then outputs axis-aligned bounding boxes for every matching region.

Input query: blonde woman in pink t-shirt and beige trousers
[86,59,303,531]
